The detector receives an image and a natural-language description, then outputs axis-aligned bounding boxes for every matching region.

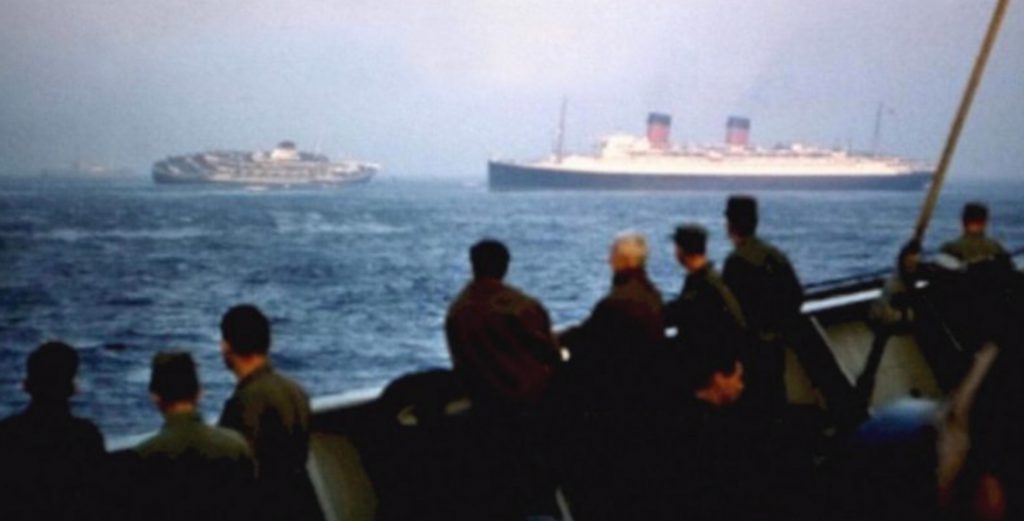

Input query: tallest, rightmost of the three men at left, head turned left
[219,304,322,520]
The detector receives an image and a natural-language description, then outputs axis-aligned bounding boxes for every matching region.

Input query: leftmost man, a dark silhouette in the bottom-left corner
[0,342,104,521]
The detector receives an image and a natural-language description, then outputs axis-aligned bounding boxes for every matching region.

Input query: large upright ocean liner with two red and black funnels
[487,113,934,190]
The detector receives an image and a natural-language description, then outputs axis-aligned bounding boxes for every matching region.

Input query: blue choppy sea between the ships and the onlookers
[0,177,1024,436]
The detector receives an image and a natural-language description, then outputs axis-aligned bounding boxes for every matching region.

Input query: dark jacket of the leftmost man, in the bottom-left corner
[0,402,105,521]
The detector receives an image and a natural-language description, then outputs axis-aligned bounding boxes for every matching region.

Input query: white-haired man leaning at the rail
[559,231,665,521]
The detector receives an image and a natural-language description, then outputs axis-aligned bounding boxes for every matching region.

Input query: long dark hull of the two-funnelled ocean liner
[487,162,932,190]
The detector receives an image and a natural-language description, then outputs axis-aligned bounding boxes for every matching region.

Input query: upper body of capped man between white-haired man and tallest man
[665,224,746,351]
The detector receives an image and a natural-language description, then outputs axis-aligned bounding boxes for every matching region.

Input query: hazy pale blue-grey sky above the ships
[0,0,1024,179]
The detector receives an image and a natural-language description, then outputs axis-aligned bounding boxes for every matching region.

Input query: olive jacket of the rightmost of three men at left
[219,363,322,519]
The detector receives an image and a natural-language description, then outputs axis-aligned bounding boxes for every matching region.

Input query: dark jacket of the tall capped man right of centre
[722,235,804,341]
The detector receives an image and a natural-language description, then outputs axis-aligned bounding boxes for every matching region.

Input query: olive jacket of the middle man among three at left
[129,413,256,521]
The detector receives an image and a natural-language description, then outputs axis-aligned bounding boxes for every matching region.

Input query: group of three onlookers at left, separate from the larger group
[0,305,321,521]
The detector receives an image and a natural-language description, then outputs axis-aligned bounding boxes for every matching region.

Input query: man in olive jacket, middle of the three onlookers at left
[130,352,256,521]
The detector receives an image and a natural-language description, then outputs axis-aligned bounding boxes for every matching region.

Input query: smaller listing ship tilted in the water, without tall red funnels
[153,141,380,186]
